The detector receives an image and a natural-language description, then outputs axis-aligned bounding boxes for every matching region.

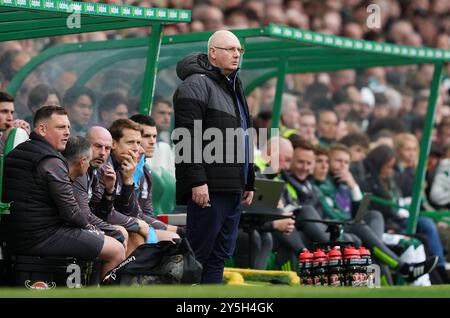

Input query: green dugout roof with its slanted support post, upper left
[0,0,191,214]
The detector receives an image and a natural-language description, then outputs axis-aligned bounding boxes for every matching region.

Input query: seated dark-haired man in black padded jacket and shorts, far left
[2,106,125,277]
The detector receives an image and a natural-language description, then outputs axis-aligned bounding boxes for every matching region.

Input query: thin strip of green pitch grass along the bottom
[0,285,450,299]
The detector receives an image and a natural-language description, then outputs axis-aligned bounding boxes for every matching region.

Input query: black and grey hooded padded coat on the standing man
[173,53,255,204]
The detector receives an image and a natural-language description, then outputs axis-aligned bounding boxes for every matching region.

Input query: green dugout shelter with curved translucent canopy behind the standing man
[5,23,450,233]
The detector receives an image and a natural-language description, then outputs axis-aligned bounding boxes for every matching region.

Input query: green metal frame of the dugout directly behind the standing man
[6,23,450,233]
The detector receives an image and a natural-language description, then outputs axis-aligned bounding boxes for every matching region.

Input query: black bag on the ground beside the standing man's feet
[103,238,203,285]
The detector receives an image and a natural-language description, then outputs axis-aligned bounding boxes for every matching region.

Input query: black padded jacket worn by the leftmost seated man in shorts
[2,132,88,252]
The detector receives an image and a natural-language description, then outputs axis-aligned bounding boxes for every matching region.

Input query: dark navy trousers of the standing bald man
[186,193,241,284]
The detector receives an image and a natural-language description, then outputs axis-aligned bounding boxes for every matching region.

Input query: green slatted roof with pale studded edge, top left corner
[0,0,191,42]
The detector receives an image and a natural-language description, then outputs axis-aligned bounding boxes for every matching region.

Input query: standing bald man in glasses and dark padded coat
[173,30,255,284]
